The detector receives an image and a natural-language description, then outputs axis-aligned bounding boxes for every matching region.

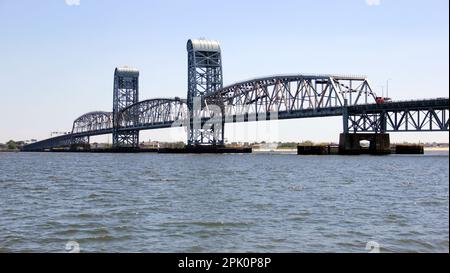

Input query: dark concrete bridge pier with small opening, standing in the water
[339,133,391,155]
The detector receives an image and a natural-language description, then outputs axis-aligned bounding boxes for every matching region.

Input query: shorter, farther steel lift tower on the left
[113,67,139,148]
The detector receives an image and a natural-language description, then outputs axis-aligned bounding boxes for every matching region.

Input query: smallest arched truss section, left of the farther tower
[72,111,113,134]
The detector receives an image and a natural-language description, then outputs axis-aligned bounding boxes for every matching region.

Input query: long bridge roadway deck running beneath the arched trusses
[24,98,449,151]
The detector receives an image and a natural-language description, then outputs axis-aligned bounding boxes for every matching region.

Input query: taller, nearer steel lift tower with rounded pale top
[187,39,224,146]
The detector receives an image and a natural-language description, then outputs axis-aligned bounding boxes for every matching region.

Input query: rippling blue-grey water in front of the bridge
[0,153,449,252]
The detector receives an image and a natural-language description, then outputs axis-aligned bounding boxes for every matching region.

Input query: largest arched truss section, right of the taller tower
[206,75,376,114]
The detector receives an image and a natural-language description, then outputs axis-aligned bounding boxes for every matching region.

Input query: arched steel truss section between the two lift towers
[120,98,188,129]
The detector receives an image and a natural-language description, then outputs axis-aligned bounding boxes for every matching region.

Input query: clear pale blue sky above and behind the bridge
[0,0,449,142]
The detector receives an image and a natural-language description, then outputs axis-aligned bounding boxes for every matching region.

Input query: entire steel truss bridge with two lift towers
[24,40,449,151]
